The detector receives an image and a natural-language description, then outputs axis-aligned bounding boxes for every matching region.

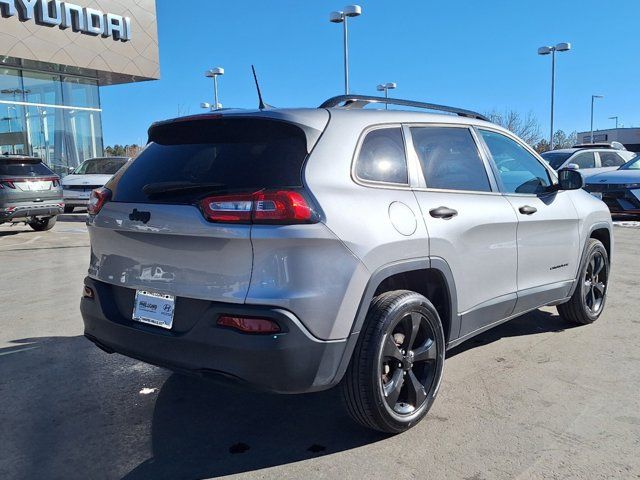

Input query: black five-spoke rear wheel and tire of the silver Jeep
[342,290,445,434]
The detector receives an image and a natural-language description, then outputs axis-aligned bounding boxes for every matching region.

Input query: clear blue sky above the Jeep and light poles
[101,0,640,145]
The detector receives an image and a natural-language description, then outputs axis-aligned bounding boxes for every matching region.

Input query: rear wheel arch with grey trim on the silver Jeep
[333,257,460,384]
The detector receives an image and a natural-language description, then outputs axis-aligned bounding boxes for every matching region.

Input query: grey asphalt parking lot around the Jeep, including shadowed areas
[0,214,640,480]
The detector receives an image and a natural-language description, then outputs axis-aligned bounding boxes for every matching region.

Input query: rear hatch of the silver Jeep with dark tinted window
[89,111,327,303]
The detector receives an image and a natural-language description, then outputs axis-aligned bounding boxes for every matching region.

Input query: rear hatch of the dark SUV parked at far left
[0,157,62,204]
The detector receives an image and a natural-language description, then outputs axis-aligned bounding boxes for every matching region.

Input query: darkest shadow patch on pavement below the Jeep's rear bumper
[124,375,386,480]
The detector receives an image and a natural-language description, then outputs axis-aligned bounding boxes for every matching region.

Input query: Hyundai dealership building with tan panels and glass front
[0,0,160,175]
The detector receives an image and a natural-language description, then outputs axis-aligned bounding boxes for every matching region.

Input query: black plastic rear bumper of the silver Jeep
[80,278,347,393]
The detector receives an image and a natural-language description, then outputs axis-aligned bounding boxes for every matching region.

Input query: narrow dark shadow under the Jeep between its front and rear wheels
[447,310,579,358]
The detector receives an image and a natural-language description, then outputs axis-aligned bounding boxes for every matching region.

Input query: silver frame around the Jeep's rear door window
[403,122,501,195]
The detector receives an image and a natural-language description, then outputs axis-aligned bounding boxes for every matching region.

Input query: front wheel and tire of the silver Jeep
[556,238,609,325]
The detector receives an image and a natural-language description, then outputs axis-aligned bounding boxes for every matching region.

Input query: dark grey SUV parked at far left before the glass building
[0,155,64,231]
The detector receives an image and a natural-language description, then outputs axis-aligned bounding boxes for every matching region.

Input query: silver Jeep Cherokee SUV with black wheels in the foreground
[81,96,613,433]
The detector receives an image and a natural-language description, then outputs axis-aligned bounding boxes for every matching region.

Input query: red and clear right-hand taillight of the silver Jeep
[200,190,316,224]
